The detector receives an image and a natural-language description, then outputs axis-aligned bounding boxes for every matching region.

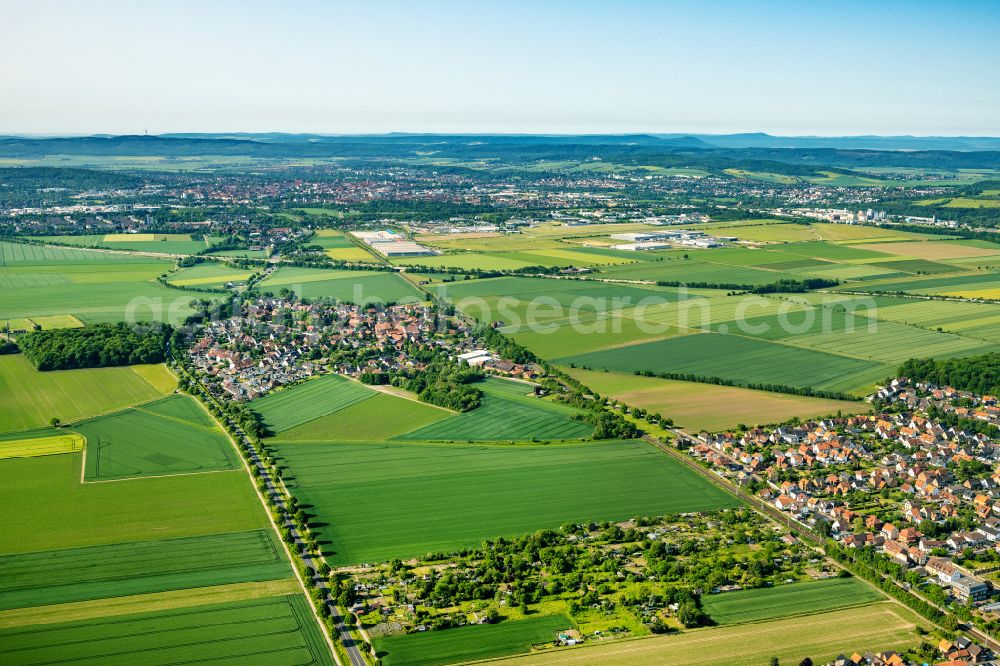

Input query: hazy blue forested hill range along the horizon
[0,133,1000,175]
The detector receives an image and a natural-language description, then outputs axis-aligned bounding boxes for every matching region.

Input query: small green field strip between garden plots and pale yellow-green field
[702,578,885,624]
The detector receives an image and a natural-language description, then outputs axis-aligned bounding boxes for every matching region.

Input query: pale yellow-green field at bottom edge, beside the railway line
[490,603,927,666]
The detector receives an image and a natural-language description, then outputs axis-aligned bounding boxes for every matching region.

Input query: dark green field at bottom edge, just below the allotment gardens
[375,615,573,666]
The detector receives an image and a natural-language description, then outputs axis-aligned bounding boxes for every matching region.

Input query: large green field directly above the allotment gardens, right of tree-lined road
[276,440,738,565]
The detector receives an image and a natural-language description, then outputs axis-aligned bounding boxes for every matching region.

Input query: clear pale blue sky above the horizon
[0,0,1000,135]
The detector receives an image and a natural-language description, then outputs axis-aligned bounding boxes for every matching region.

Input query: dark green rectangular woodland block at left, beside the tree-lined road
[17,322,172,370]
